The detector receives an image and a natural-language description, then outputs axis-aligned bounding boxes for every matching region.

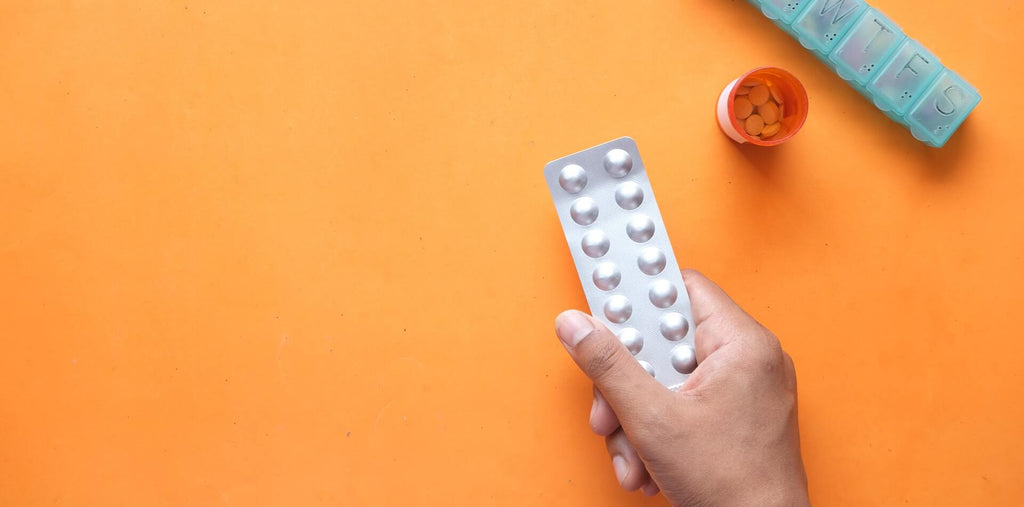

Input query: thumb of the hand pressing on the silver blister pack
[555,310,669,425]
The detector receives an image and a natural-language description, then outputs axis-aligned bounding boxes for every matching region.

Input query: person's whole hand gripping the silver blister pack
[555,270,810,506]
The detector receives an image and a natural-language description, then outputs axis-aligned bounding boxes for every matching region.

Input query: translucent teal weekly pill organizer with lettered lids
[748,0,981,147]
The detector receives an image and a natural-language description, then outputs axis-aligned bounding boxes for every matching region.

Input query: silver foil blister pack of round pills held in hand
[544,137,697,389]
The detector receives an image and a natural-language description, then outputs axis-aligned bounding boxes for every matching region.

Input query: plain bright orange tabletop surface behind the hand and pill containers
[0,0,1024,506]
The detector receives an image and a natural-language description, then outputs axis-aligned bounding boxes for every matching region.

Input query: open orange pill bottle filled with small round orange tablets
[716,67,807,146]
